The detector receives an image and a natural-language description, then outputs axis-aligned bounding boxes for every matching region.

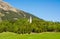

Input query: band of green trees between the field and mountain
[0,18,60,34]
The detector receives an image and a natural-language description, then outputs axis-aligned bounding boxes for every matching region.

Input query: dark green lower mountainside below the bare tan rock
[0,8,40,20]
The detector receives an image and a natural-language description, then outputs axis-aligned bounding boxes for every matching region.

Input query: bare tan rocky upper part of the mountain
[0,0,17,12]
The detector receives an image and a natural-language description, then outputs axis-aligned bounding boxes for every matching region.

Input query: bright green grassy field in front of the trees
[0,32,60,39]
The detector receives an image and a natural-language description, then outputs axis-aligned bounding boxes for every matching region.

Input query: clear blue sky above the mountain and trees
[4,0,60,21]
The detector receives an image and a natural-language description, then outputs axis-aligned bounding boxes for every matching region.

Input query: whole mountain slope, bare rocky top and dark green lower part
[0,1,42,20]
